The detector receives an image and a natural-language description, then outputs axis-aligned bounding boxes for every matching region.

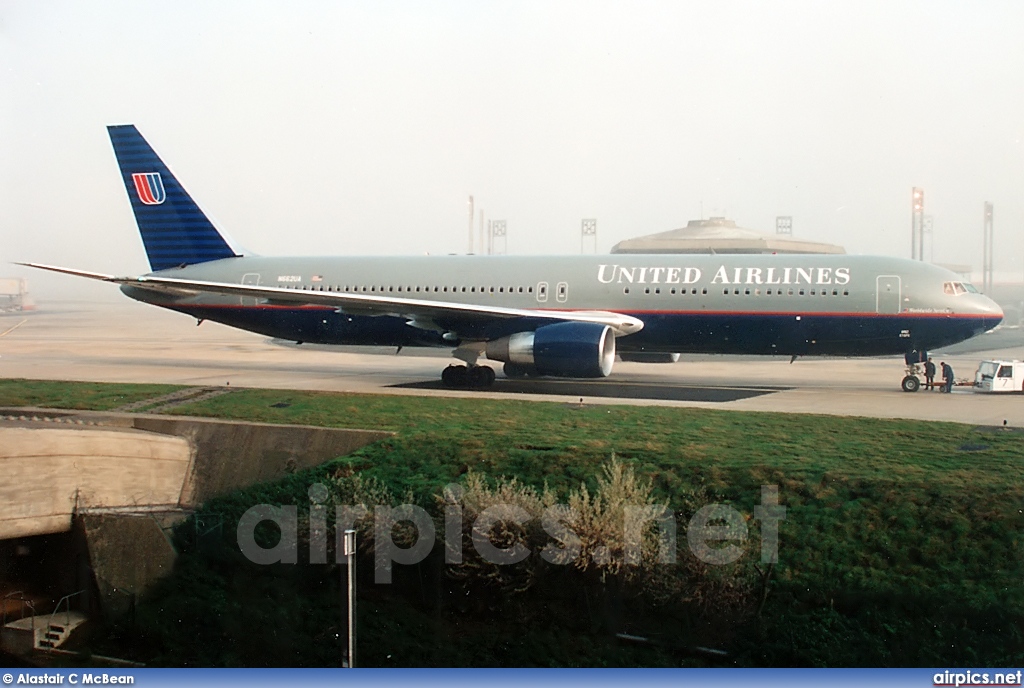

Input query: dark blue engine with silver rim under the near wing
[486,323,615,378]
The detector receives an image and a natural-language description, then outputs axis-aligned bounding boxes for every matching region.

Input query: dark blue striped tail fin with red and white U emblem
[106,124,237,271]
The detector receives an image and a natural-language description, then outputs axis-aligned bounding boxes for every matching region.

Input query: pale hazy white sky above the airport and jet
[0,0,1024,298]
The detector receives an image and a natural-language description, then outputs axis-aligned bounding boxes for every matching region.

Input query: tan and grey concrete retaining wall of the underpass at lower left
[0,409,392,614]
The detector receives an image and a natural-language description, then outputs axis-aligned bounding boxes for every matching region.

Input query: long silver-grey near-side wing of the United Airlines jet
[17,263,643,339]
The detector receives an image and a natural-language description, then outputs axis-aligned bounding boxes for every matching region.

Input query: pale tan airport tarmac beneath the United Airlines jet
[0,300,1024,427]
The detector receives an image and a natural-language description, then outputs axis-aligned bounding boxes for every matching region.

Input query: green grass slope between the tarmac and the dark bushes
[0,381,1024,665]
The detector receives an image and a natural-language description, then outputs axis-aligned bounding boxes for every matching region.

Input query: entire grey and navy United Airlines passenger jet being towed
[19,125,1002,391]
